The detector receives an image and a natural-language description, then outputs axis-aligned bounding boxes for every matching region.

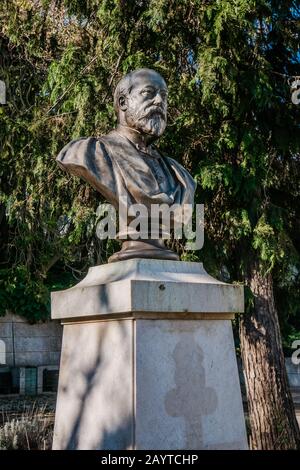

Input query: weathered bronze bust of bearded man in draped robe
[57,69,195,262]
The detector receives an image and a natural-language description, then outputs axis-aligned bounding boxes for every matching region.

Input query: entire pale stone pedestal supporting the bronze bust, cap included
[52,259,247,450]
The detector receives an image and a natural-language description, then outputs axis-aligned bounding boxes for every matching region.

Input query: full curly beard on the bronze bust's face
[126,106,167,137]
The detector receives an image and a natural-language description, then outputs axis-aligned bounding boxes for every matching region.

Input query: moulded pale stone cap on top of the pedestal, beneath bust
[51,259,244,319]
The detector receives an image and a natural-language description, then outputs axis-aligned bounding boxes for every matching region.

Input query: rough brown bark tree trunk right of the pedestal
[240,263,300,450]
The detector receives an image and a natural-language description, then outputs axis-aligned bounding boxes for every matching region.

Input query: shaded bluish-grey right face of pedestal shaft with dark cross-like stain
[136,320,247,449]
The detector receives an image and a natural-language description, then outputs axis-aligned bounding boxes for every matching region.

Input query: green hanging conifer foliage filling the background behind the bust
[0,0,300,334]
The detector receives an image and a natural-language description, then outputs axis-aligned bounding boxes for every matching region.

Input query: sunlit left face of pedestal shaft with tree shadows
[53,320,134,450]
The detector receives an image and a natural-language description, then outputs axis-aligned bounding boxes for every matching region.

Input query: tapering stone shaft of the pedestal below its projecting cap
[54,320,247,450]
